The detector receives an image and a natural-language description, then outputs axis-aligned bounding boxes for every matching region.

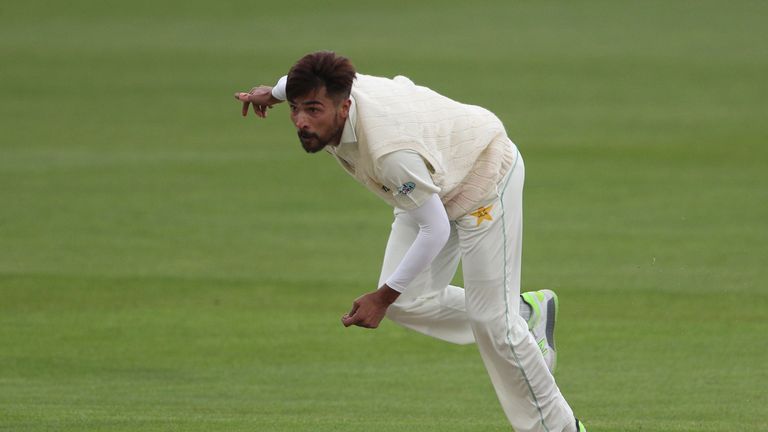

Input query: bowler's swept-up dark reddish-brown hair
[285,51,355,102]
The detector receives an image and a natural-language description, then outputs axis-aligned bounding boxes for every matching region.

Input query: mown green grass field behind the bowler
[0,0,768,432]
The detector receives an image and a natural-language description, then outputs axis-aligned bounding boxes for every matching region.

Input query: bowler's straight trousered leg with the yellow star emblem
[457,158,574,432]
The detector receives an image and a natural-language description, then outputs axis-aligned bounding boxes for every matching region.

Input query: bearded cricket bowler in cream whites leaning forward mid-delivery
[235,52,586,432]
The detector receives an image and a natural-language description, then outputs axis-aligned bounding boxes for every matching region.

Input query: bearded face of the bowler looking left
[289,87,351,153]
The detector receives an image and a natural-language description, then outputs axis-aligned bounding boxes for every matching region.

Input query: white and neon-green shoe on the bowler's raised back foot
[520,290,559,374]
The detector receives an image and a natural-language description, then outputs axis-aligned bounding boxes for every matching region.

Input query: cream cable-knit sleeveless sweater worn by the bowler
[342,74,518,220]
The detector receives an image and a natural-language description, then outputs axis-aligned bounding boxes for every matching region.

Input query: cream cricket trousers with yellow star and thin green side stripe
[379,153,574,432]
